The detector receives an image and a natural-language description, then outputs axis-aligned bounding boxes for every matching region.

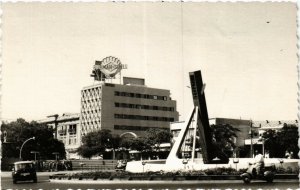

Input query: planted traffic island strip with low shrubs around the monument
[49,168,298,181]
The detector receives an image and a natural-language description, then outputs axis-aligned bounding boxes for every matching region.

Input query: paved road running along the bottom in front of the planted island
[1,173,299,190]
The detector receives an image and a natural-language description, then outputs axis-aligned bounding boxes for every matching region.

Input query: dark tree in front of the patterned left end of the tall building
[77,129,119,159]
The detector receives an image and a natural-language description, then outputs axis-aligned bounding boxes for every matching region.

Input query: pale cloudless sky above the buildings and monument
[1,2,298,120]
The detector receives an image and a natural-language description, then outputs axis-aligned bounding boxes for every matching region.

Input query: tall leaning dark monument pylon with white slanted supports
[166,71,229,164]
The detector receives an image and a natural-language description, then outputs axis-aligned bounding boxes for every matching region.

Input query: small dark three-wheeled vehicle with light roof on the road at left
[12,161,37,183]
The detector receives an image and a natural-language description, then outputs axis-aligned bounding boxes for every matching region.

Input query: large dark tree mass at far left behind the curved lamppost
[1,119,66,160]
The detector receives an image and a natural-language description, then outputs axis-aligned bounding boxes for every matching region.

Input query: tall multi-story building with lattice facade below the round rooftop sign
[80,78,179,136]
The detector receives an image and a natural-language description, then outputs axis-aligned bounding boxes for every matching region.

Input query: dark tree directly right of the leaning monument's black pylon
[211,124,239,157]
